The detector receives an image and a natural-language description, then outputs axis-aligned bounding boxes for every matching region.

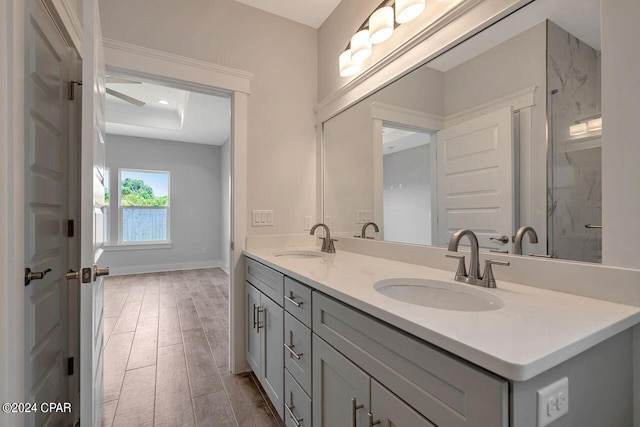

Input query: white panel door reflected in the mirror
[436,107,514,249]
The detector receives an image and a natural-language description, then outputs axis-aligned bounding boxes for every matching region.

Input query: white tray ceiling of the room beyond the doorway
[106,83,231,145]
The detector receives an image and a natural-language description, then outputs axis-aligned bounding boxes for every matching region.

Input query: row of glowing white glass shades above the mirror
[338,0,432,77]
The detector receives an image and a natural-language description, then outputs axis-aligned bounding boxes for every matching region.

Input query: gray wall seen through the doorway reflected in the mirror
[383,144,431,245]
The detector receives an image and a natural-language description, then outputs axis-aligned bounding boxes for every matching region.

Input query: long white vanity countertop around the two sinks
[245,247,640,381]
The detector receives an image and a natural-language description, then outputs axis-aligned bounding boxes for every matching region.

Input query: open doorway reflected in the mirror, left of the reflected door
[381,123,435,245]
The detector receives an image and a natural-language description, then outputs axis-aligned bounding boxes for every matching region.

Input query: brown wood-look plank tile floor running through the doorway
[103,268,282,427]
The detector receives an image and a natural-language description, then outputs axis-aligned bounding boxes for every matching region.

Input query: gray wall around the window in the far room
[104,135,223,274]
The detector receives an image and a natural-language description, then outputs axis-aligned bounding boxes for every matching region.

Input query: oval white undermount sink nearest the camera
[373,279,504,311]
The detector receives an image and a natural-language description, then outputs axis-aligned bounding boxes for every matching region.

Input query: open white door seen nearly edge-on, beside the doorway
[80,0,105,426]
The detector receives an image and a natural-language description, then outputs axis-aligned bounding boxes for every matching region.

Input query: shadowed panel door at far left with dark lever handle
[24,0,71,426]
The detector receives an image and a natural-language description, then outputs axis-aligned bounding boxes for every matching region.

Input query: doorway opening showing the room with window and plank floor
[103,76,239,425]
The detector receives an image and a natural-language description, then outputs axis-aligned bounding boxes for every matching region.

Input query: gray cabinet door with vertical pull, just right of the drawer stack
[312,334,370,427]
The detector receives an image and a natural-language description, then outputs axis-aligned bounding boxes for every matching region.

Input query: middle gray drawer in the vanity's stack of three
[284,312,311,396]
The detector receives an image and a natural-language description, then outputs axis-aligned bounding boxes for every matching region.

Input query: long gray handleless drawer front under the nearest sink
[313,292,509,427]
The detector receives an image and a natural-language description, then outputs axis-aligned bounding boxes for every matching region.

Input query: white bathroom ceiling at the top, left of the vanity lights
[230,0,340,28]
